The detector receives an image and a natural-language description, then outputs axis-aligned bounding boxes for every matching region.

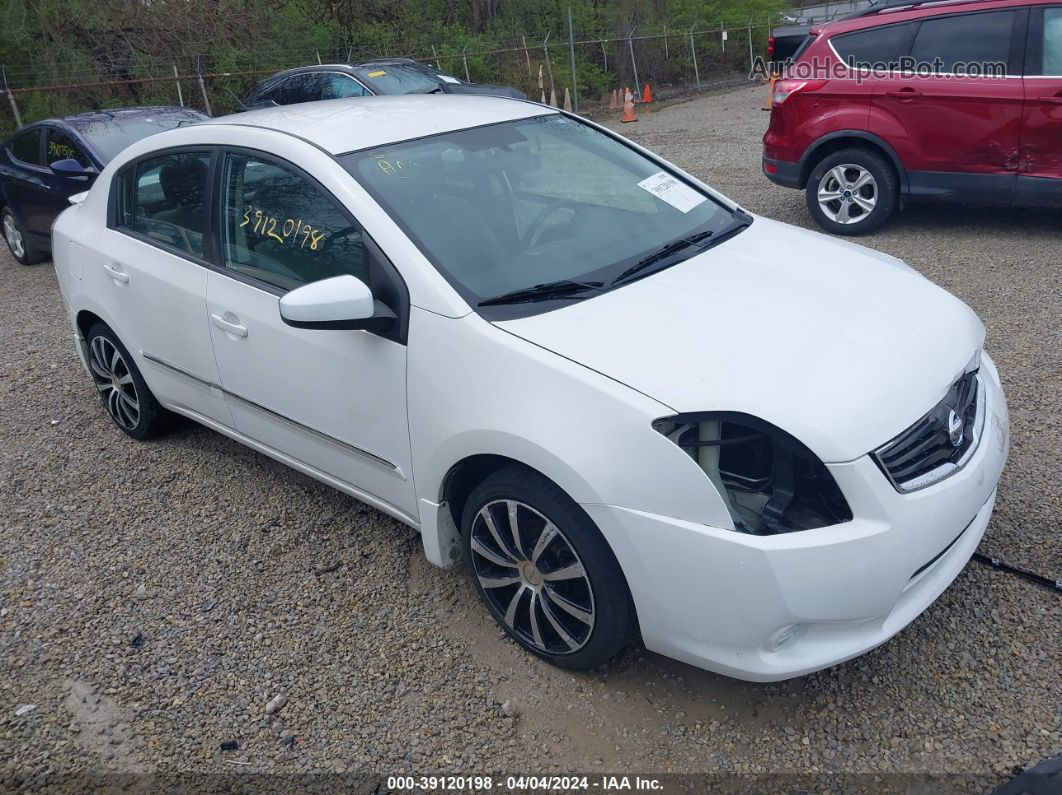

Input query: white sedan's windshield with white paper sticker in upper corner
[340,115,735,314]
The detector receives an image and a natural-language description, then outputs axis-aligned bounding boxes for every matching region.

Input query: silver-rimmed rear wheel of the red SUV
[804,149,900,235]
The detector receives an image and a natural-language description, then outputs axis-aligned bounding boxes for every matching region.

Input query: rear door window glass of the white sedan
[117,152,212,257]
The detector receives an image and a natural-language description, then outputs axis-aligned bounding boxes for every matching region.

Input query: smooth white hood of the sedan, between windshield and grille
[496,218,984,462]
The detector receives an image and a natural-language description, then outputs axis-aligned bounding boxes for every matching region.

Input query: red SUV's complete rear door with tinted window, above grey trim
[870,8,1027,204]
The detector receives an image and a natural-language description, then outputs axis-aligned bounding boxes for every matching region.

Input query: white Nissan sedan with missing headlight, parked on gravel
[53,96,1008,680]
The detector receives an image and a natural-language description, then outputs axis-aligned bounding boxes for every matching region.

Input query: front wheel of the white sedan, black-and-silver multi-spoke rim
[461,466,635,670]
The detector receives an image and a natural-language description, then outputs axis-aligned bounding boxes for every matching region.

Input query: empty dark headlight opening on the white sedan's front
[653,412,852,535]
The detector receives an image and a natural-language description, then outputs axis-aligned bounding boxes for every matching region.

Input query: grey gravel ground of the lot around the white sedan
[0,89,1062,791]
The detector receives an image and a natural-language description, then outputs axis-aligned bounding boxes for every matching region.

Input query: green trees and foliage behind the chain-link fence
[0,0,784,133]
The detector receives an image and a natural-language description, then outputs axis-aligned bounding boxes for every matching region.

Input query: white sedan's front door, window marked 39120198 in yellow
[207,152,416,520]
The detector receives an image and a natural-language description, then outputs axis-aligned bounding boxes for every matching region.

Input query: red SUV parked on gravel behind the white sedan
[764,0,1062,235]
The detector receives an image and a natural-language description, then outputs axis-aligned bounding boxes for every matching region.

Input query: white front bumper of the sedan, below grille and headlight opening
[583,356,1008,681]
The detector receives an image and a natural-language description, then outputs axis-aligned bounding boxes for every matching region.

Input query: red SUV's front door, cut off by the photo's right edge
[1014,4,1062,206]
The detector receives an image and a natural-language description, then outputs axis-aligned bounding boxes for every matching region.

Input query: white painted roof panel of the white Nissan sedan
[204,93,558,155]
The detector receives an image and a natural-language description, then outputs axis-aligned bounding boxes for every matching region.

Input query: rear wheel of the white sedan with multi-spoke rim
[86,323,173,439]
